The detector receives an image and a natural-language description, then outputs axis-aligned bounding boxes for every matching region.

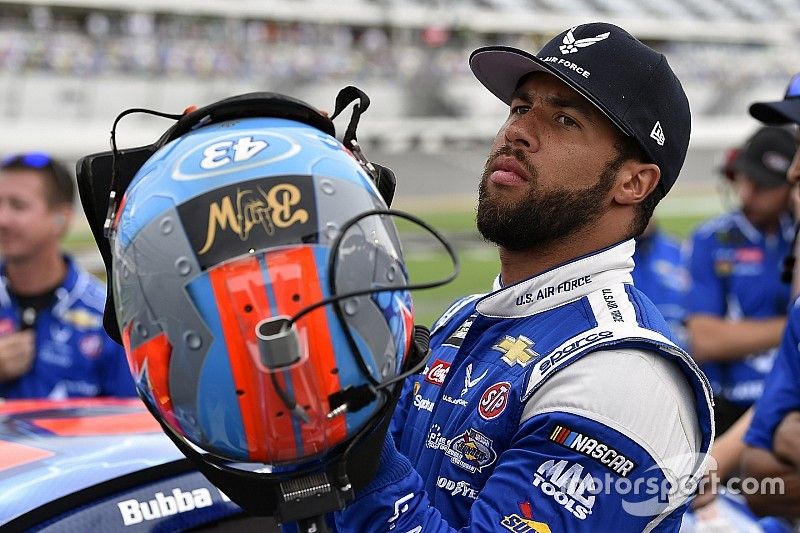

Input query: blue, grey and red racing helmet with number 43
[109,116,413,464]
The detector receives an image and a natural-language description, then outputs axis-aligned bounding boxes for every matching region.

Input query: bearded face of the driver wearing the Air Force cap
[477,73,619,250]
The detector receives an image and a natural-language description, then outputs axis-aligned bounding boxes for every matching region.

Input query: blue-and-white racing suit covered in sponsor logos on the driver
[335,240,713,533]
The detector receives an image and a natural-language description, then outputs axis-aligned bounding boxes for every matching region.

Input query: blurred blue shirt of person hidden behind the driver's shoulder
[631,219,687,350]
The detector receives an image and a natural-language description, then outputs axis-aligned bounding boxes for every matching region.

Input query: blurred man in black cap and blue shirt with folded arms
[685,127,794,433]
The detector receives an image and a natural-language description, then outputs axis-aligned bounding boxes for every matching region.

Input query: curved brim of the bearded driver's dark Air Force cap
[469,46,633,136]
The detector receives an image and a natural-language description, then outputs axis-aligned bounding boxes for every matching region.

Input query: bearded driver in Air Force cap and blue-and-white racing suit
[336,23,713,533]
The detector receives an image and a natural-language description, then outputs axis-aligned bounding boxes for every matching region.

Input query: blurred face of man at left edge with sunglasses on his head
[0,170,65,261]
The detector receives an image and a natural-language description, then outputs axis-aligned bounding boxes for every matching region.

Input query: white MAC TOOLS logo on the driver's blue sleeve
[533,459,596,520]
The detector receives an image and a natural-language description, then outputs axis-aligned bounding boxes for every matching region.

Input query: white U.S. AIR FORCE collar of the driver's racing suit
[475,239,636,318]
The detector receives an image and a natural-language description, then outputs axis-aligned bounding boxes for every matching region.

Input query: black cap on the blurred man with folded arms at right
[732,126,795,187]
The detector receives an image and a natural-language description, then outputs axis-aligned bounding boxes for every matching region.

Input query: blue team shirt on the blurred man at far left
[0,257,136,399]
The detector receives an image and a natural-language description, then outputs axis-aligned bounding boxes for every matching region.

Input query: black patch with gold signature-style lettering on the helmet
[178,176,317,268]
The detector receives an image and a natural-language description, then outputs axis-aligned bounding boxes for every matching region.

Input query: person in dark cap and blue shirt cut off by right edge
[742,74,800,520]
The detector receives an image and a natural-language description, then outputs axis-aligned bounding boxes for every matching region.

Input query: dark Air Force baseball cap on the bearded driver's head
[469,22,691,194]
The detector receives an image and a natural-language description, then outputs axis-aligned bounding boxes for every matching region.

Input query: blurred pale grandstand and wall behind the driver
[0,0,800,206]
